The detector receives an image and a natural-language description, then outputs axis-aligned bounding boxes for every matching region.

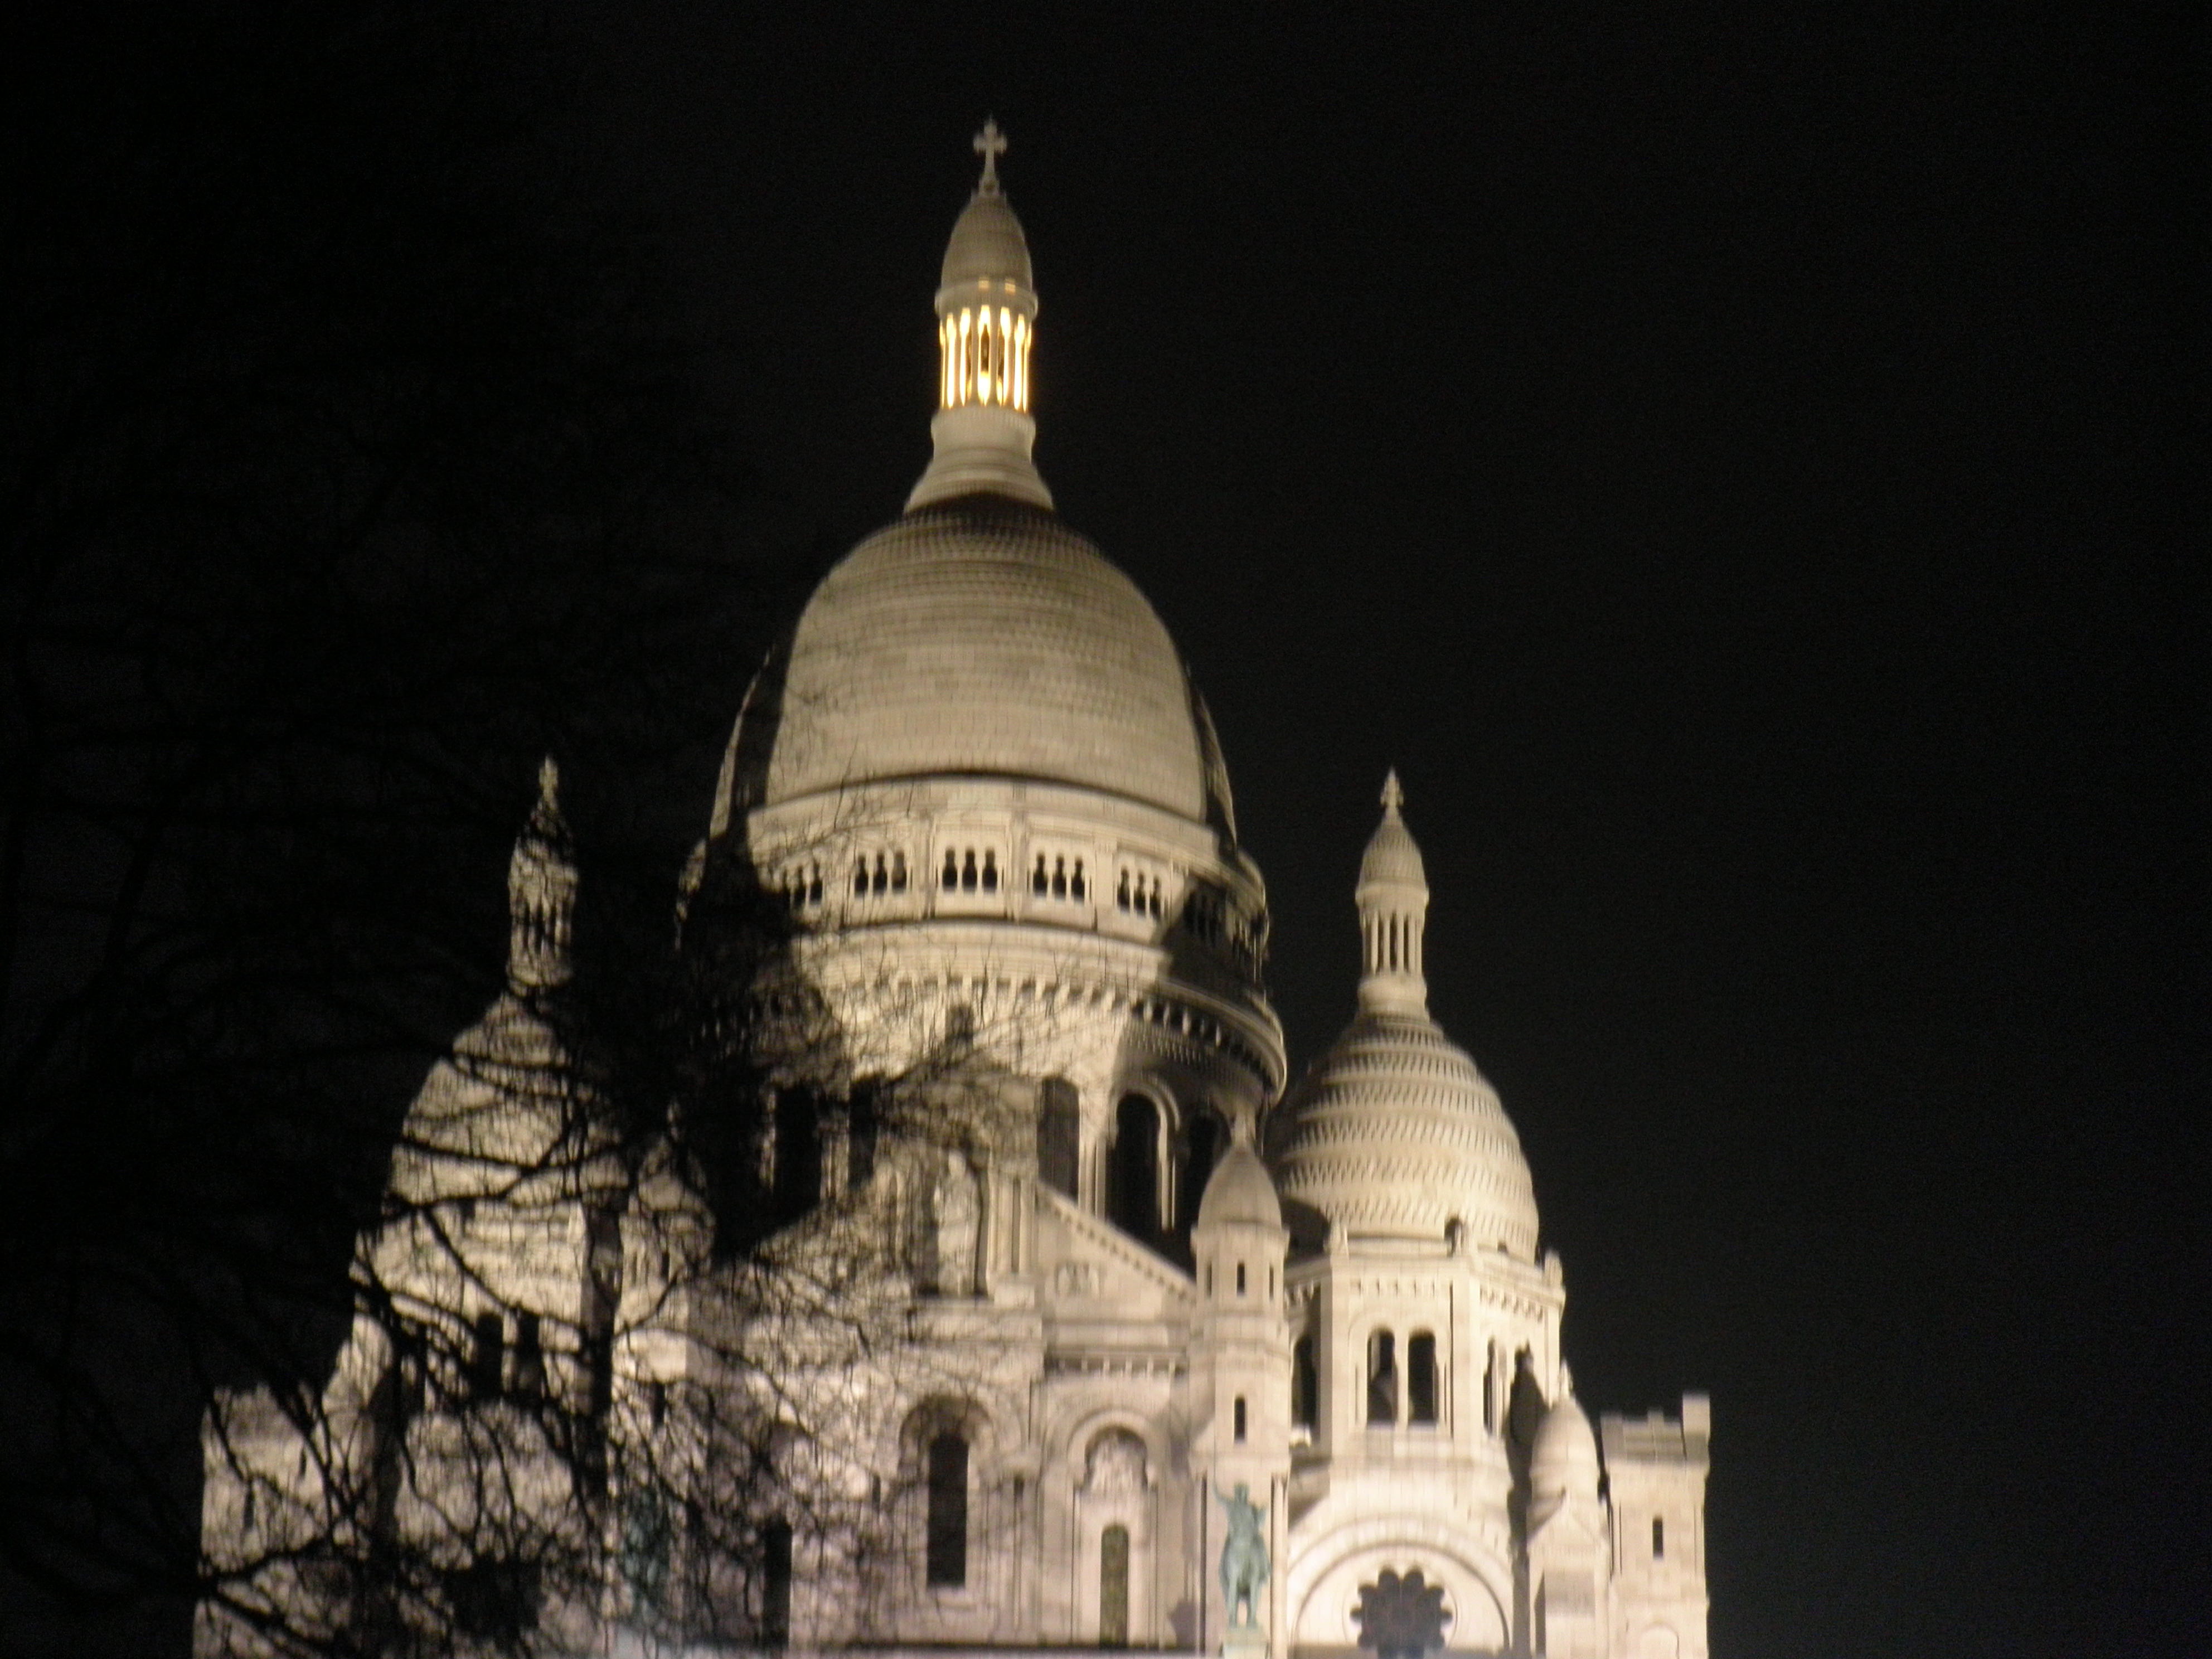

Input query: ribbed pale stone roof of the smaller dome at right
[1274,1011,1537,1261]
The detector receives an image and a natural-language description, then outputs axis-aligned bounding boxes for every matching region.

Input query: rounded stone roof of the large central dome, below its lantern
[768,496,1206,821]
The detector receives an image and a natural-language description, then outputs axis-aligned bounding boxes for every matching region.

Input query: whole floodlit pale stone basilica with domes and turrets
[195,128,1710,1659]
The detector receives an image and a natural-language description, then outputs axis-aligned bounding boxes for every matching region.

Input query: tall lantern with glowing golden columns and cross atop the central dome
[907,119,1053,511]
